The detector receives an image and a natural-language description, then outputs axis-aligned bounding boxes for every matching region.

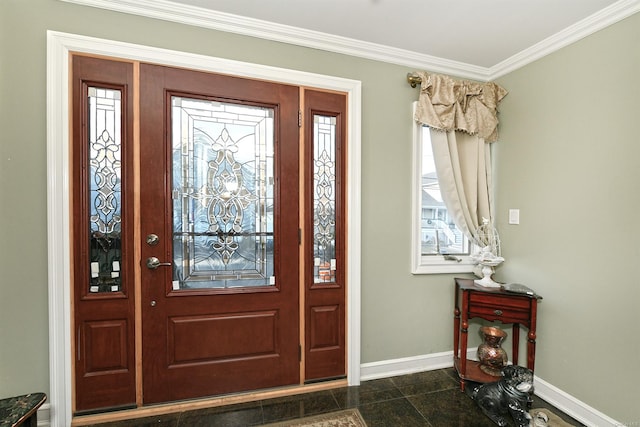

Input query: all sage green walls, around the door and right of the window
[0,0,640,420]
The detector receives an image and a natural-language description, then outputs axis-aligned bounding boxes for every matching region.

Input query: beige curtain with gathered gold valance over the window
[414,72,507,241]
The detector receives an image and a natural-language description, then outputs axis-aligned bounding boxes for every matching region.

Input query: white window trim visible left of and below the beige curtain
[411,102,476,274]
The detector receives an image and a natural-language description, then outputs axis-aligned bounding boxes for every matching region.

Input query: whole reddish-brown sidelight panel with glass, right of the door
[304,89,347,381]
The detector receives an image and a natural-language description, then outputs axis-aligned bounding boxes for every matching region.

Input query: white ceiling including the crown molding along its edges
[63,0,640,78]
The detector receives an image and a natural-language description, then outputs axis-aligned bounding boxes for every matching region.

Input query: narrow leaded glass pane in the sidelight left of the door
[88,87,122,293]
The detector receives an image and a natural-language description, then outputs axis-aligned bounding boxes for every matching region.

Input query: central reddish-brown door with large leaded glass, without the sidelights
[140,64,300,404]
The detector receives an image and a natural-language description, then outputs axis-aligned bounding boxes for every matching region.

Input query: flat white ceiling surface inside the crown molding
[173,0,617,67]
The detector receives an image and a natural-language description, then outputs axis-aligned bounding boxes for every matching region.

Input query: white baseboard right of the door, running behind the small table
[360,348,623,427]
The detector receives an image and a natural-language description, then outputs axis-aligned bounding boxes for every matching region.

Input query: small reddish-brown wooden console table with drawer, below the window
[453,278,542,391]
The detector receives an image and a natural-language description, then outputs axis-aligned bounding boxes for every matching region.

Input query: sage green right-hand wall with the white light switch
[496,10,640,425]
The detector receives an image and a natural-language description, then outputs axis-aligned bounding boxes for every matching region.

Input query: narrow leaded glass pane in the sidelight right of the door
[313,115,336,283]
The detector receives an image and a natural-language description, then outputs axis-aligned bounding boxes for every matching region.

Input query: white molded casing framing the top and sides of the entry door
[47,31,362,427]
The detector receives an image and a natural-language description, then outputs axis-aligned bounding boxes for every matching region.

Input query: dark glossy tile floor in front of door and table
[81,369,582,427]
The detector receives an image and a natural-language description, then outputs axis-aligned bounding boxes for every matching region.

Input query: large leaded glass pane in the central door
[172,97,275,290]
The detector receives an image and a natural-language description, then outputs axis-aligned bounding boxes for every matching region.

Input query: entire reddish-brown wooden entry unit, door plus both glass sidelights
[71,55,347,413]
